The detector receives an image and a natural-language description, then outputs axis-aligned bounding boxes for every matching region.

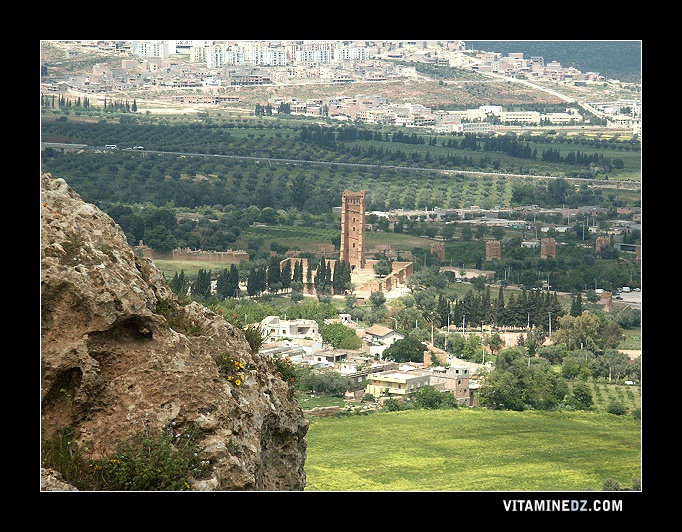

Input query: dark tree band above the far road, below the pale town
[41,114,638,185]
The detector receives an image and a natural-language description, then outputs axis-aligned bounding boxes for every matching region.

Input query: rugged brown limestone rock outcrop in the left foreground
[40,174,308,491]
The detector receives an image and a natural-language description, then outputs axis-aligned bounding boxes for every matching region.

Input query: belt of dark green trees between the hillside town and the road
[42,116,636,189]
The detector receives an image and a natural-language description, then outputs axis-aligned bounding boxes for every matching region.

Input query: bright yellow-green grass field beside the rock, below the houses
[305,408,642,491]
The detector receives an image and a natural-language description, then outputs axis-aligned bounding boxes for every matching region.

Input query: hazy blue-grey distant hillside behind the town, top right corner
[464,41,642,83]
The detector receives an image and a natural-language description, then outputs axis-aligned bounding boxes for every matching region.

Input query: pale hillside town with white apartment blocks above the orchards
[41,40,641,134]
